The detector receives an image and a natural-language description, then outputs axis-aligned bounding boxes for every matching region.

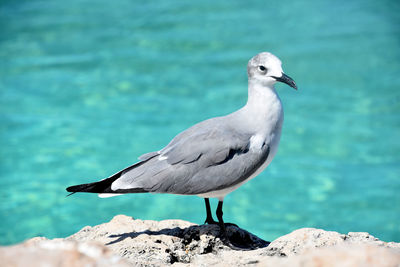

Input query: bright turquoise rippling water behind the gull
[0,0,400,245]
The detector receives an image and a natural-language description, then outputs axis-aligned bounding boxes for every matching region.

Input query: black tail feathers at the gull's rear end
[66,161,152,196]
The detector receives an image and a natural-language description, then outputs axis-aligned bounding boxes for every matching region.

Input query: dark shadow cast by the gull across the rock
[106,224,271,253]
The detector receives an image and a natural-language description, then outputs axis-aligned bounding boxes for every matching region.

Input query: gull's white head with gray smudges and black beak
[247,52,297,90]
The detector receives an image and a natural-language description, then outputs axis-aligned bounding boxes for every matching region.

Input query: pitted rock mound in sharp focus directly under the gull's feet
[67,215,268,266]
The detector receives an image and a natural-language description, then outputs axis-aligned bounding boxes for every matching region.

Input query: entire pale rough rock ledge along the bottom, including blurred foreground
[0,215,400,266]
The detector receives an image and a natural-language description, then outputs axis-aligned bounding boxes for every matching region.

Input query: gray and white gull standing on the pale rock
[67,52,297,240]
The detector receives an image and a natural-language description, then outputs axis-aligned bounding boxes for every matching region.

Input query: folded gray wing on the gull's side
[111,120,269,194]
